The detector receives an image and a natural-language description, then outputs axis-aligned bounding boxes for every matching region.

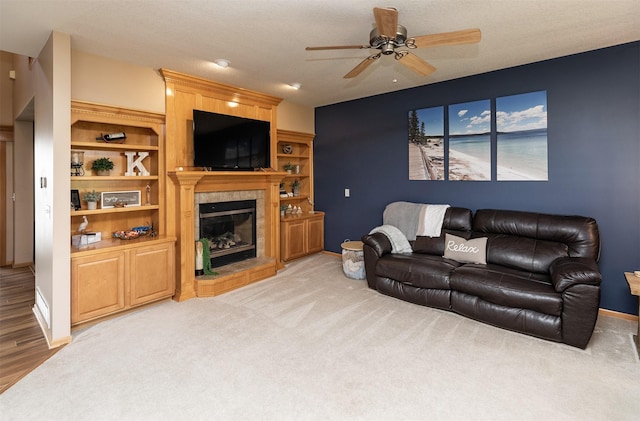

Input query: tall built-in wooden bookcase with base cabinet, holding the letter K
[70,101,176,324]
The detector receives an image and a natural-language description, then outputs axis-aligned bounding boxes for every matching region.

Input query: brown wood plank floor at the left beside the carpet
[0,267,62,393]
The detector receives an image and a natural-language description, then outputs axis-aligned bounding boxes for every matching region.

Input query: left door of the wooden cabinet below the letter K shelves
[71,251,125,324]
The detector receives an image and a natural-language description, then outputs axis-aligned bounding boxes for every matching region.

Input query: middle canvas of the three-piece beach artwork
[448,99,491,181]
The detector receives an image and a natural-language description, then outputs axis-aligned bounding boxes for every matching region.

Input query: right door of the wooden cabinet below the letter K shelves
[129,243,175,306]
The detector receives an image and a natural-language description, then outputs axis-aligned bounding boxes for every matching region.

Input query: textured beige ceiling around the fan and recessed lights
[0,0,640,107]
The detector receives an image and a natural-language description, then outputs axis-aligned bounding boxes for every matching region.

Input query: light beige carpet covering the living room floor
[0,254,640,420]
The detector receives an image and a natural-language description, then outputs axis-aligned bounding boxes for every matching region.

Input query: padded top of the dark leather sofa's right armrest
[549,257,602,292]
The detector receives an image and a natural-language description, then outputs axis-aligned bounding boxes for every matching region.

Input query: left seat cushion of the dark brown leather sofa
[376,253,460,289]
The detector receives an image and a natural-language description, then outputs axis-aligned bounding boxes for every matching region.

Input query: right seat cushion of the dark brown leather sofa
[449,264,562,316]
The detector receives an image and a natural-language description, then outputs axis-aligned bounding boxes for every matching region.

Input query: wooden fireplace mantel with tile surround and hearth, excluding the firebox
[169,171,286,301]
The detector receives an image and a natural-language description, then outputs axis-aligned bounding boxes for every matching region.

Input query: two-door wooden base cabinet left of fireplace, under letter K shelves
[71,240,175,325]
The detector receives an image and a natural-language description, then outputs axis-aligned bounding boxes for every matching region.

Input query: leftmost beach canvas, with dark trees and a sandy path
[409,107,444,180]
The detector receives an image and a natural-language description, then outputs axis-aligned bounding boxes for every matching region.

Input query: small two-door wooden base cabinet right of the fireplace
[280,212,324,262]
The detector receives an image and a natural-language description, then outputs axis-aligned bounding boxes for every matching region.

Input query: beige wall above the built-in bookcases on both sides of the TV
[71,50,315,133]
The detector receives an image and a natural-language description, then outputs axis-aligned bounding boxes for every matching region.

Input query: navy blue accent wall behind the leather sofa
[314,42,640,314]
